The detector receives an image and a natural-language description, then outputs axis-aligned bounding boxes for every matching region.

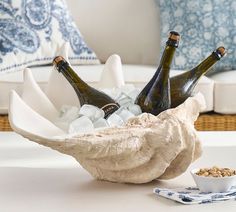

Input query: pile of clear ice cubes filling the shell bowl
[54,85,142,133]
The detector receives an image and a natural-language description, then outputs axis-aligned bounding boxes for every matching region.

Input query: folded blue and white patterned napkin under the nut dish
[153,186,236,205]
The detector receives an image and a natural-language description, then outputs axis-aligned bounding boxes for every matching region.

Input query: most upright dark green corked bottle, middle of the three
[135,31,180,115]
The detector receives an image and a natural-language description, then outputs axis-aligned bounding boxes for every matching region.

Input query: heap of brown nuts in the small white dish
[196,166,236,177]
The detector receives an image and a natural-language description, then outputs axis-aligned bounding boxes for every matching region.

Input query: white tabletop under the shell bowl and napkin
[0,132,236,212]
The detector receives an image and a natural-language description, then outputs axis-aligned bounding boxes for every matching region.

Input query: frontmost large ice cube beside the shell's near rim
[68,116,94,134]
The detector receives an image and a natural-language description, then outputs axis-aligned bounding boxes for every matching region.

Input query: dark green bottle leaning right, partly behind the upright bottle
[170,46,226,108]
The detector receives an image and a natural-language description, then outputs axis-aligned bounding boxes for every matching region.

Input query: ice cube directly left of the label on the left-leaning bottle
[79,104,105,122]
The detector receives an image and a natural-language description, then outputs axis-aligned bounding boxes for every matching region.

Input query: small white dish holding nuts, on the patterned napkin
[190,168,236,193]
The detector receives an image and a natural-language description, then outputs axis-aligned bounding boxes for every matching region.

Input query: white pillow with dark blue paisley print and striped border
[0,0,99,73]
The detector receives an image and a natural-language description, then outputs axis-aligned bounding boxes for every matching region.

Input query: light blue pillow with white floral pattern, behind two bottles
[156,0,236,71]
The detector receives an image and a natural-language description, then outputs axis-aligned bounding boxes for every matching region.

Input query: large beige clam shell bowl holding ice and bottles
[9,53,205,183]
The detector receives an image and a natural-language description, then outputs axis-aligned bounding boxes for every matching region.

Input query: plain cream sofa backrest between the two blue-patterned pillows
[67,0,160,65]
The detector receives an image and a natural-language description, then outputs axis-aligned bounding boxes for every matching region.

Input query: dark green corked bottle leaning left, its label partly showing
[53,56,120,118]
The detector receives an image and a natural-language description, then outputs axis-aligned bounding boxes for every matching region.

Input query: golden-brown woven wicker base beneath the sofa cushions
[0,113,236,131]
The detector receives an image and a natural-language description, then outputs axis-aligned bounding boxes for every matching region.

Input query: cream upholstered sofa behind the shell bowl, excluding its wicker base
[0,0,236,114]
